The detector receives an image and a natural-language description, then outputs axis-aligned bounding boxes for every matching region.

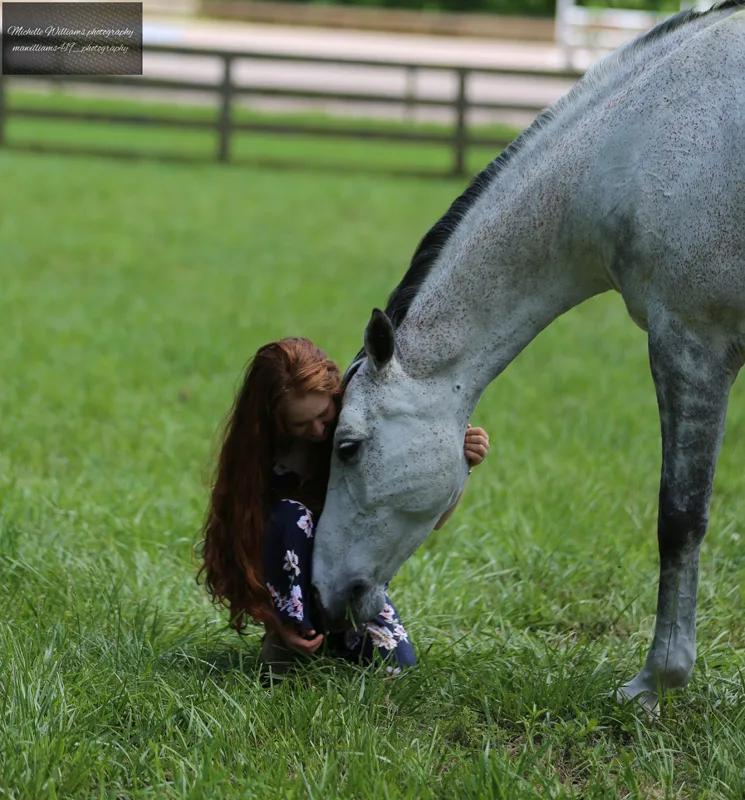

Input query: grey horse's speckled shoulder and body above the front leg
[593,11,745,331]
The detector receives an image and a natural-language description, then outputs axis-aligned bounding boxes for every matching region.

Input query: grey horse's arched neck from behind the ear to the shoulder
[396,6,741,418]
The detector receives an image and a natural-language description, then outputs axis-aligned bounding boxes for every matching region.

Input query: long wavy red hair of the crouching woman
[199,338,341,631]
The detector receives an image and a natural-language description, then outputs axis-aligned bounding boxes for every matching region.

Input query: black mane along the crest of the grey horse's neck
[353,0,745,363]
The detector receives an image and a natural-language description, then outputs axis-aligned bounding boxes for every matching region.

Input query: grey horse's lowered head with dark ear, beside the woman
[313,309,467,622]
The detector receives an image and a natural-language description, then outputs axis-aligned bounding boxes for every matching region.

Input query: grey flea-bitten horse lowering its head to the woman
[313,0,745,708]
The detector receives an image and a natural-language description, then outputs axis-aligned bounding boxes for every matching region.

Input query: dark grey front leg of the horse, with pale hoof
[619,313,739,712]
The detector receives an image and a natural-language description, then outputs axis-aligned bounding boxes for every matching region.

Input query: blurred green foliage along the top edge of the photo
[264,0,680,17]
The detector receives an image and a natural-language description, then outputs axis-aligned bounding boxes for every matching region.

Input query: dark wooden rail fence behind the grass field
[0,45,581,176]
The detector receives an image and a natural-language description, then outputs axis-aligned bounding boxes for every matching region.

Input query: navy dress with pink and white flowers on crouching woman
[264,465,416,672]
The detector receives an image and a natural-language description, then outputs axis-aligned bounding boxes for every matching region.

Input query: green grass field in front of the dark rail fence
[0,103,745,800]
